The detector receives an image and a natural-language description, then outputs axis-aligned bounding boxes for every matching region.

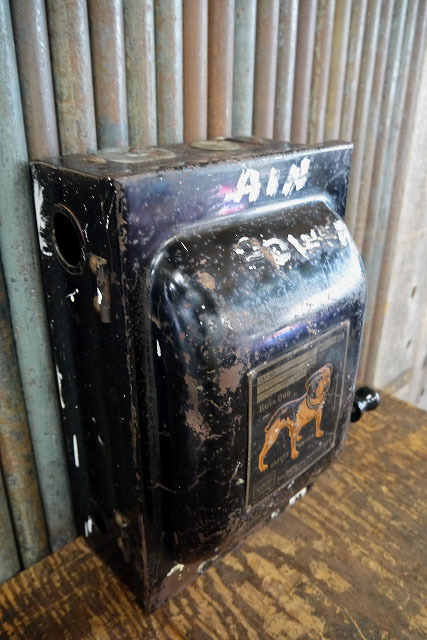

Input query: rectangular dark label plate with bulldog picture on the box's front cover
[246,322,348,506]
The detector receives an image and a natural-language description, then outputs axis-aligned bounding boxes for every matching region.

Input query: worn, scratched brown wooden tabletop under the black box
[0,397,427,640]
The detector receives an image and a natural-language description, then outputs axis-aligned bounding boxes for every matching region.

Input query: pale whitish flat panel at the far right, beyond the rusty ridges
[367,2,427,396]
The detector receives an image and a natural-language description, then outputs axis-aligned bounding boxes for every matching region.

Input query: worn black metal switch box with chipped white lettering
[32,139,365,610]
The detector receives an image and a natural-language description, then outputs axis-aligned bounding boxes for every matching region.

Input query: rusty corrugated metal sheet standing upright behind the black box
[0,0,427,579]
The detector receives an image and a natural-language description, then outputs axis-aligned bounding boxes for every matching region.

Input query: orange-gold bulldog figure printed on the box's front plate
[258,363,332,471]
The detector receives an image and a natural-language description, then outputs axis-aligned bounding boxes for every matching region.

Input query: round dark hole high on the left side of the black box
[52,205,85,274]
